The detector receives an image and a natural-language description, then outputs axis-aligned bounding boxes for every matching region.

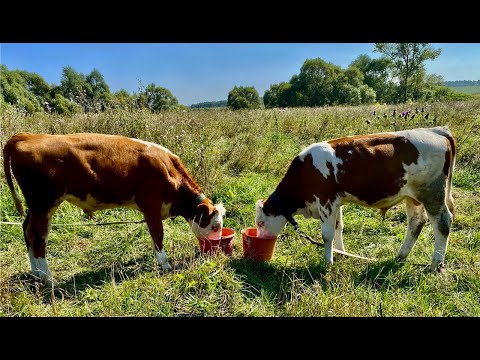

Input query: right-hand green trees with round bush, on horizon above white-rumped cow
[228,43,466,109]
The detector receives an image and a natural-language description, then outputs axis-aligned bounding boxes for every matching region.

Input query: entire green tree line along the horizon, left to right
[0,43,475,114]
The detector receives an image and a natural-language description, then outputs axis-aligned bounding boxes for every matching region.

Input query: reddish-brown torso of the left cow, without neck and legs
[7,133,180,208]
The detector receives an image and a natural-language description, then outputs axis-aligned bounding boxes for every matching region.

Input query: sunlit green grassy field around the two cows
[0,100,480,317]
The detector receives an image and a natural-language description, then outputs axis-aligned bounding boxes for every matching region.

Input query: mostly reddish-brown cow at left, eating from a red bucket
[3,133,225,283]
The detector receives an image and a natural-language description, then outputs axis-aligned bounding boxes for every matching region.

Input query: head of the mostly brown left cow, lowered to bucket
[189,198,225,239]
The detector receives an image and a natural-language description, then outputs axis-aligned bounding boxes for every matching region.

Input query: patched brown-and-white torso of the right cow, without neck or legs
[296,127,454,207]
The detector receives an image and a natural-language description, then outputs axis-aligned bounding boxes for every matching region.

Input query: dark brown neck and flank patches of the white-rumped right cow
[263,134,419,216]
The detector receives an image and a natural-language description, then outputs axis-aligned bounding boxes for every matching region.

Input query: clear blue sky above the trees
[0,43,480,105]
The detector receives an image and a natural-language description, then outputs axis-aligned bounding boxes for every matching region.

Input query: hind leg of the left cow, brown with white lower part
[23,211,53,286]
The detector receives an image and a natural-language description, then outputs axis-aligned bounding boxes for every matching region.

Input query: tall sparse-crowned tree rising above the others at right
[375,43,442,102]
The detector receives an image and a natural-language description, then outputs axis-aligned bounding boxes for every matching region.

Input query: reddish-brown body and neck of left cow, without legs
[4,133,214,224]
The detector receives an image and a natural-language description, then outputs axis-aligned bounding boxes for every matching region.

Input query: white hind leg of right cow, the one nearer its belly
[397,198,427,259]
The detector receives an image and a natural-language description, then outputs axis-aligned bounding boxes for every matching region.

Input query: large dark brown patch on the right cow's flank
[328,134,419,205]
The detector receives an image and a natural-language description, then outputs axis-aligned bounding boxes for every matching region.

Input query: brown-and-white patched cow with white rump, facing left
[255,127,456,271]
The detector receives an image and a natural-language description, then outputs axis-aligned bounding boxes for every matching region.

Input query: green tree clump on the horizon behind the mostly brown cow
[0,64,184,114]
